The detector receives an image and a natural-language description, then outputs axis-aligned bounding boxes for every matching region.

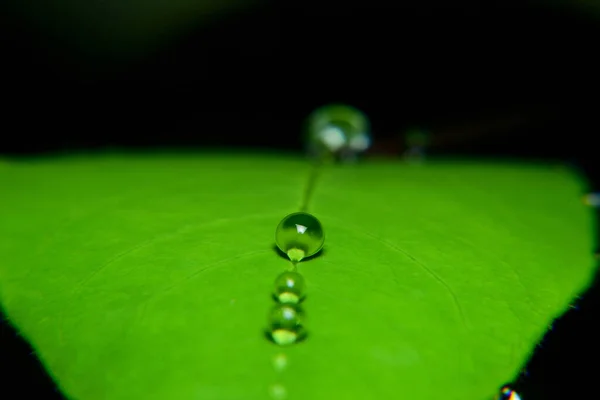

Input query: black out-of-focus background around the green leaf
[0,0,600,400]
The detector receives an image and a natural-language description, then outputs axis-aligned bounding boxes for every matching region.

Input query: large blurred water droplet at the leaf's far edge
[307,104,371,161]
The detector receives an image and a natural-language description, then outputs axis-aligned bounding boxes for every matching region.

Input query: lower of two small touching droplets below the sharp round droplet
[268,304,306,346]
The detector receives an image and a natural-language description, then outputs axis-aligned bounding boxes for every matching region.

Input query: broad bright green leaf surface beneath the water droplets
[0,154,593,400]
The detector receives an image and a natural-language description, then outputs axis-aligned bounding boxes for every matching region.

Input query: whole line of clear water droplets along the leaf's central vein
[266,105,370,400]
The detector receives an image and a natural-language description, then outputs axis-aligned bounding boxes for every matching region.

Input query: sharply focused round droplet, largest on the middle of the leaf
[275,212,325,262]
